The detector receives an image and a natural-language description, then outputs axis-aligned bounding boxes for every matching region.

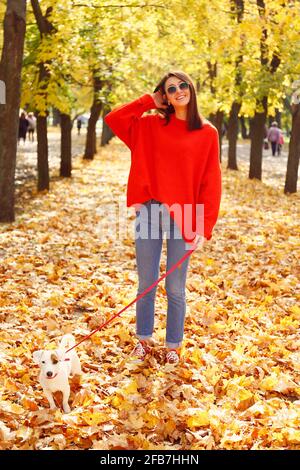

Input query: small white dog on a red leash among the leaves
[33,334,82,413]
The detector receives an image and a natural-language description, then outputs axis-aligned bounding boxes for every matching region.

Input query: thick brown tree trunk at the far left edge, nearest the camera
[0,0,26,222]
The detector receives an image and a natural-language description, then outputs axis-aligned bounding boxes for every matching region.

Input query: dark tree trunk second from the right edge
[249,96,268,180]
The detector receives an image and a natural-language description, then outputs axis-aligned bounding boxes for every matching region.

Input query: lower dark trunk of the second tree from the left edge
[36,115,49,191]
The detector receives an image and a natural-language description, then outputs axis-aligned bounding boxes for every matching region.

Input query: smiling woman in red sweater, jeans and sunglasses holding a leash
[105,71,221,363]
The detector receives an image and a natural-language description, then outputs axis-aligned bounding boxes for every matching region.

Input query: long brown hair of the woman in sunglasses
[154,70,204,131]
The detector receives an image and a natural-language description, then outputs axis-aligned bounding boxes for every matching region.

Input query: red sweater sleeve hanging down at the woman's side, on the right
[198,128,222,240]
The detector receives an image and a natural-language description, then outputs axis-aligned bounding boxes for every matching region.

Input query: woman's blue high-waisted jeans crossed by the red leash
[135,199,191,348]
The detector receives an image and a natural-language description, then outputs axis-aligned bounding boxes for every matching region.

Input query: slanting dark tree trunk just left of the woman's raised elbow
[83,71,102,160]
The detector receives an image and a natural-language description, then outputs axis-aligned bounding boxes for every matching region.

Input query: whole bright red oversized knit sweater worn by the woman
[104,93,221,243]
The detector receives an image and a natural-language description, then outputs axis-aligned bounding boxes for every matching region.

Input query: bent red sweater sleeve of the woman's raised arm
[104,93,156,150]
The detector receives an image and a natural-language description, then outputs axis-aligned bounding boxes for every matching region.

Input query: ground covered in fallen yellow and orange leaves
[0,136,300,449]
